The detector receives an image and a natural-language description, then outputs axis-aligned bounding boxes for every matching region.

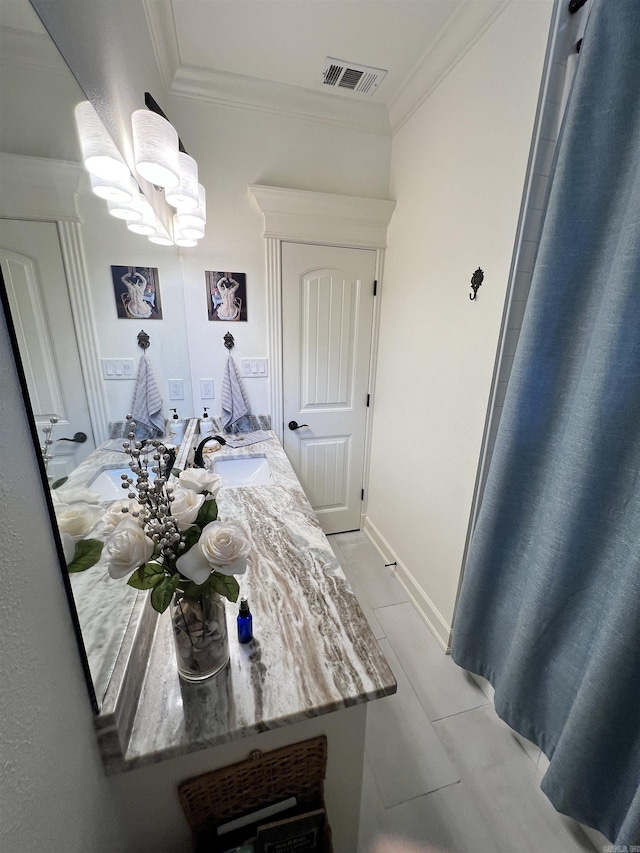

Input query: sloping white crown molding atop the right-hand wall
[389,0,512,134]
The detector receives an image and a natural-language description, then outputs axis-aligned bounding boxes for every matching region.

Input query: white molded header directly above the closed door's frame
[249,184,396,249]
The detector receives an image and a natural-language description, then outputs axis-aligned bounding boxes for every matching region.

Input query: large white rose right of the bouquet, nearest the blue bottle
[176,521,251,584]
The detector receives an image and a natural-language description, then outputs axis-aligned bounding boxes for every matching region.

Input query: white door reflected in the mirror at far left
[0,219,95,482]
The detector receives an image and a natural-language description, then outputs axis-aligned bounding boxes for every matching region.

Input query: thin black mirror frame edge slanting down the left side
[0,269,100,714]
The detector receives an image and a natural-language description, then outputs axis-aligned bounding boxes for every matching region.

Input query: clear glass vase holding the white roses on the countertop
[171,592,229,681]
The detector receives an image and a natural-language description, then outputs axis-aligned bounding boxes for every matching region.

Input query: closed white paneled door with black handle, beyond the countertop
[282,243,376,533]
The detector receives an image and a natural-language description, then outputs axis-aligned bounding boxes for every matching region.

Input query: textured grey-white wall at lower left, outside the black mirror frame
[0,300,135,853]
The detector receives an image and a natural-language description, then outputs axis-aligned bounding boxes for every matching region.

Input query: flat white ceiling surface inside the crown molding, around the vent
[172,0,458,104]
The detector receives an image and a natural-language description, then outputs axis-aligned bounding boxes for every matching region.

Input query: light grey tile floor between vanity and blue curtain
[329,532,606,853]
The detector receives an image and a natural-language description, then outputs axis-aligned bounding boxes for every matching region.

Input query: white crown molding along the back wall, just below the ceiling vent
[171,66,390,136]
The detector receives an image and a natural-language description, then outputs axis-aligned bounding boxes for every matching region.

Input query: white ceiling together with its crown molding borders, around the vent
[143,0,511,133]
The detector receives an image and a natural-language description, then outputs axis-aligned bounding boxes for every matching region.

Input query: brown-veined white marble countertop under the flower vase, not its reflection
[114,432,396,773]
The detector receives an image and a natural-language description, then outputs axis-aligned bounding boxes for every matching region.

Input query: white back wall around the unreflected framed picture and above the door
[167,97,391,422]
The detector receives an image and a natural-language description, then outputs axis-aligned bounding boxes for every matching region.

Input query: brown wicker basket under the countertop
[178,735,333,853]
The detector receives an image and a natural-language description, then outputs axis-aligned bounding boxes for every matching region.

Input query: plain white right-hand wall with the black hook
[367,0,551,642]
